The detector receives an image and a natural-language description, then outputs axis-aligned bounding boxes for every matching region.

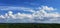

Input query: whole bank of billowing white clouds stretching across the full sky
[0,6,60,23]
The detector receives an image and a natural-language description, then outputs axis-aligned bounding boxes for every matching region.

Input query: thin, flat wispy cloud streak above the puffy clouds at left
[0,6,35,12]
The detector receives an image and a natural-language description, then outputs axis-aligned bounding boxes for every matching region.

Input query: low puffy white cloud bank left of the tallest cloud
[0,11,32,19]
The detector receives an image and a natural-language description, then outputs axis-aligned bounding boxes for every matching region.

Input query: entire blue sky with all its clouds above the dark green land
[0,0,60,23]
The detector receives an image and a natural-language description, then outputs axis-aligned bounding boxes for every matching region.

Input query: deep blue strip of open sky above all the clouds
[0,0,60,11]
